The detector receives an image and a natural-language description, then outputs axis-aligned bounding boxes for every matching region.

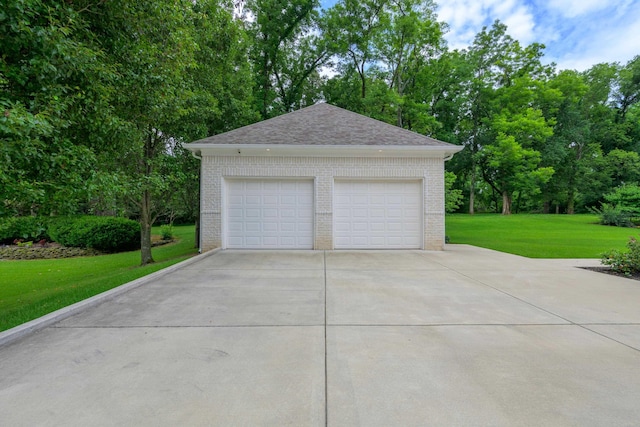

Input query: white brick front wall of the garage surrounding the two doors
[200,156,444,251]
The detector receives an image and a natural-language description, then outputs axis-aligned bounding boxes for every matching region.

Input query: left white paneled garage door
[226,179,313,249]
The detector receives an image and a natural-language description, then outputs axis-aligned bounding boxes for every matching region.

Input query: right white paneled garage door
[334,181,423,249]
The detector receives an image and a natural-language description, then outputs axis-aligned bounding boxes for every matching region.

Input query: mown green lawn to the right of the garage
[446,214,640,258]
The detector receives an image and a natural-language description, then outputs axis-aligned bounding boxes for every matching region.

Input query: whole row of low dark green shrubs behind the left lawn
[0,216,140,252]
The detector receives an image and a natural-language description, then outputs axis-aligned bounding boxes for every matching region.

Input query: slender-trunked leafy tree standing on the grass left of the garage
[90,0,197,265]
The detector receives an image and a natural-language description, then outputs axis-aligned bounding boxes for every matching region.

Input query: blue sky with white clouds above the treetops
[320,0,640,71]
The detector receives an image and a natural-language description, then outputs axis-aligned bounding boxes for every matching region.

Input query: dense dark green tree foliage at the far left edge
[0,0,113,215]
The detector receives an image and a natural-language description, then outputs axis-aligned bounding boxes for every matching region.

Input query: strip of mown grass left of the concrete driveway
[0,226,197,331]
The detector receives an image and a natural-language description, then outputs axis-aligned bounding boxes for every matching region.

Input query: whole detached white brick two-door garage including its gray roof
[186,104,461,250]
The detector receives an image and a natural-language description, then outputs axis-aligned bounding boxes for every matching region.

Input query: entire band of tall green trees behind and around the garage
[0,0,640,264]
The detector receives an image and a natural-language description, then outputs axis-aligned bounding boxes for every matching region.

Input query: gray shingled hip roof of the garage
[194,103,460,147]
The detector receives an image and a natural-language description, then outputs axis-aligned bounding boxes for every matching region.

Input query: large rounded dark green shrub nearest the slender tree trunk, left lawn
[50,216,140,252]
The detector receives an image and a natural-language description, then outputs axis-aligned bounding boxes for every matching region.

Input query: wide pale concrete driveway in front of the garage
[0,245,640,427]
